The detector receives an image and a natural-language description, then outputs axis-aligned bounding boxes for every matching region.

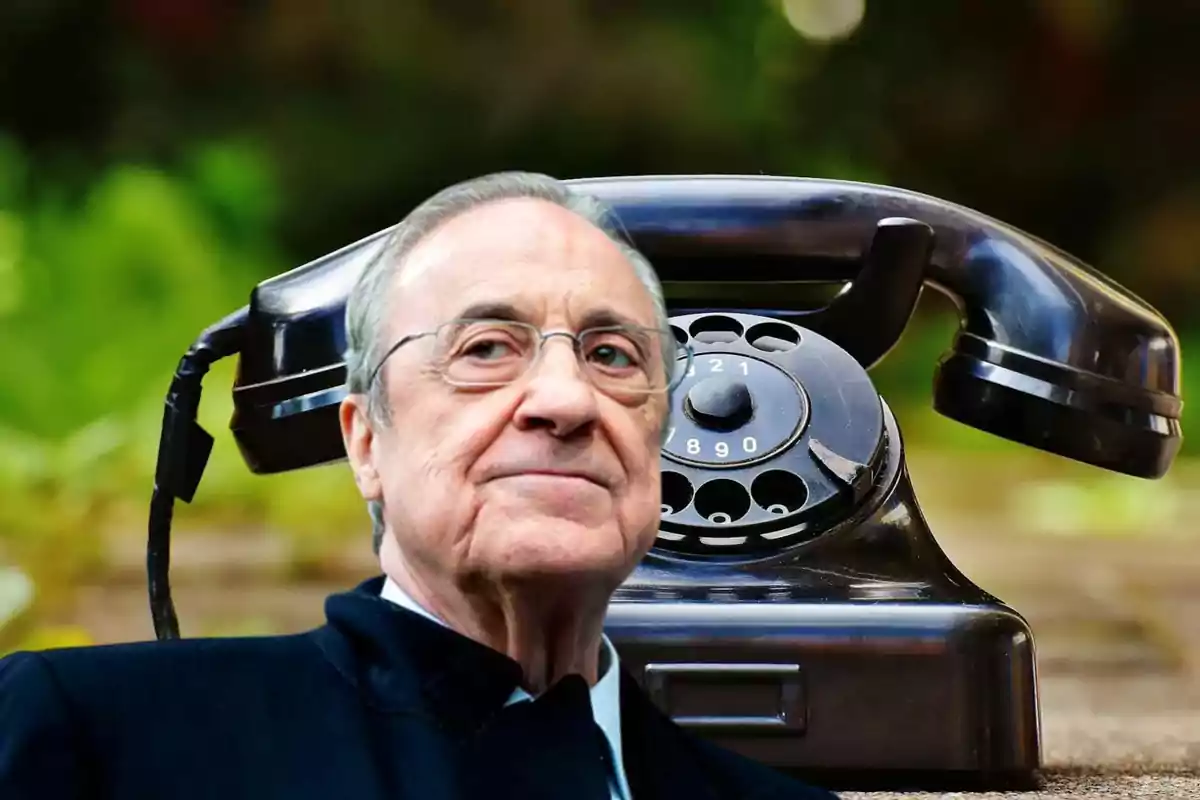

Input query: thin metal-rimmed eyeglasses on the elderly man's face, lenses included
[367,319,692,398]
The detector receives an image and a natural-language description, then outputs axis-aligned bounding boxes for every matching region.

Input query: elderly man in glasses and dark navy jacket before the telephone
[0,174,832,800]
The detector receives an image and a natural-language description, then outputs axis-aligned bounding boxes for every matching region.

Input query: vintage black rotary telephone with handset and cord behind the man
[148,176,1182,786]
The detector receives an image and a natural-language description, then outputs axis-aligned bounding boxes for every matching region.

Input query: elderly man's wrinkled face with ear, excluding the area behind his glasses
[343,199,666,590]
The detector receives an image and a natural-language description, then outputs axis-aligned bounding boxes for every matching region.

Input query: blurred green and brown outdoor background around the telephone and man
[0,0,1200,700]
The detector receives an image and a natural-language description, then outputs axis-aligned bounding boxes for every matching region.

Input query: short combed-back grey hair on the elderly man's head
[346,173,677,553]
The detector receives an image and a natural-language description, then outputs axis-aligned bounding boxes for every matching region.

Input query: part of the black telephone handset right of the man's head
[580,176,1182,477]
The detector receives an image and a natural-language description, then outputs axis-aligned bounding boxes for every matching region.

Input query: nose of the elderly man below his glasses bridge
[515,337,599,438]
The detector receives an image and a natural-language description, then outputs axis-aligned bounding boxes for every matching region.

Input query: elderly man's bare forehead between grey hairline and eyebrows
[389,199,656,335]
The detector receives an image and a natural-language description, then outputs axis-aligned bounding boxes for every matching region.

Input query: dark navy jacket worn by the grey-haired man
[0,578,834,800]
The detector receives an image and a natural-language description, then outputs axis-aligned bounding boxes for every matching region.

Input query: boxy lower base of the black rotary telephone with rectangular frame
[606,599,1040,789]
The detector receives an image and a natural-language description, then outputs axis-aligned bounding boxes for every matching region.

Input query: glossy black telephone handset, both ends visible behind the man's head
[233,176,1182,477]
